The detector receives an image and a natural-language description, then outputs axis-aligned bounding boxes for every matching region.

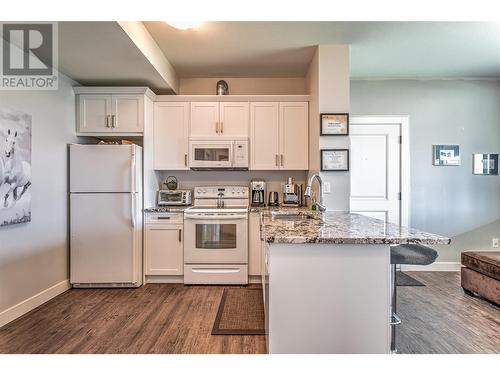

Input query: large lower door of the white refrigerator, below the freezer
[70,193,138,283]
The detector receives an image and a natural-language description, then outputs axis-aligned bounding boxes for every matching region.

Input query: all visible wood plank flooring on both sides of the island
[0,272,500,353]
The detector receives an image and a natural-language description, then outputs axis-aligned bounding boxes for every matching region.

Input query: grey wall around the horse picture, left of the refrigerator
[0,74,76,313]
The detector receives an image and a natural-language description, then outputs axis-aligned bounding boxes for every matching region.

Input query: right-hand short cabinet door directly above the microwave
[219,102,249,138]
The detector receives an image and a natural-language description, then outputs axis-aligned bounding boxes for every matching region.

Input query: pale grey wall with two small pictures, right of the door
[351,80,500,261]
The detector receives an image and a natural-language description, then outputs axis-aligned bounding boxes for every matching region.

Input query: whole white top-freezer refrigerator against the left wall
[69,144,142,288]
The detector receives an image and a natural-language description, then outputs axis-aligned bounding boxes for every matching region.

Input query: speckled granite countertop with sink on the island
[261,209,450,245]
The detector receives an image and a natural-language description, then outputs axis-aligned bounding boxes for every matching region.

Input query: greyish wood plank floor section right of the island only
[396,272,500,354]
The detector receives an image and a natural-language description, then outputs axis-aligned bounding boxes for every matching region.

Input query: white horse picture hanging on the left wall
[0,109,31,227]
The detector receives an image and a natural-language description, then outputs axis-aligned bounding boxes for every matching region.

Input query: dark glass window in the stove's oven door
[196,224,236,249]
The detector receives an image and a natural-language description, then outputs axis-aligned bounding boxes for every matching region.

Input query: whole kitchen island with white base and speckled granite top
[261,210,450,353]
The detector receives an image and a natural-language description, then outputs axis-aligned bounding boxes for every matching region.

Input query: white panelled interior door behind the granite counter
[350,124,402,224]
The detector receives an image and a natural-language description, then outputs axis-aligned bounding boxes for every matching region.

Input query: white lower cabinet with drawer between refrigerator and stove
[144,213,184,276]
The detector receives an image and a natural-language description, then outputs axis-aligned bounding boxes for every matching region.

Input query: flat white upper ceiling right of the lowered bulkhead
[144,22,500,79]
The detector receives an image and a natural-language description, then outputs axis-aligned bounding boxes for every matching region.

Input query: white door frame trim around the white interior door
[349,115,411,227]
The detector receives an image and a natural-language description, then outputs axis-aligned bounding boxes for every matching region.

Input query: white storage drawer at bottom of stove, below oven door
[184,264,248,285]
